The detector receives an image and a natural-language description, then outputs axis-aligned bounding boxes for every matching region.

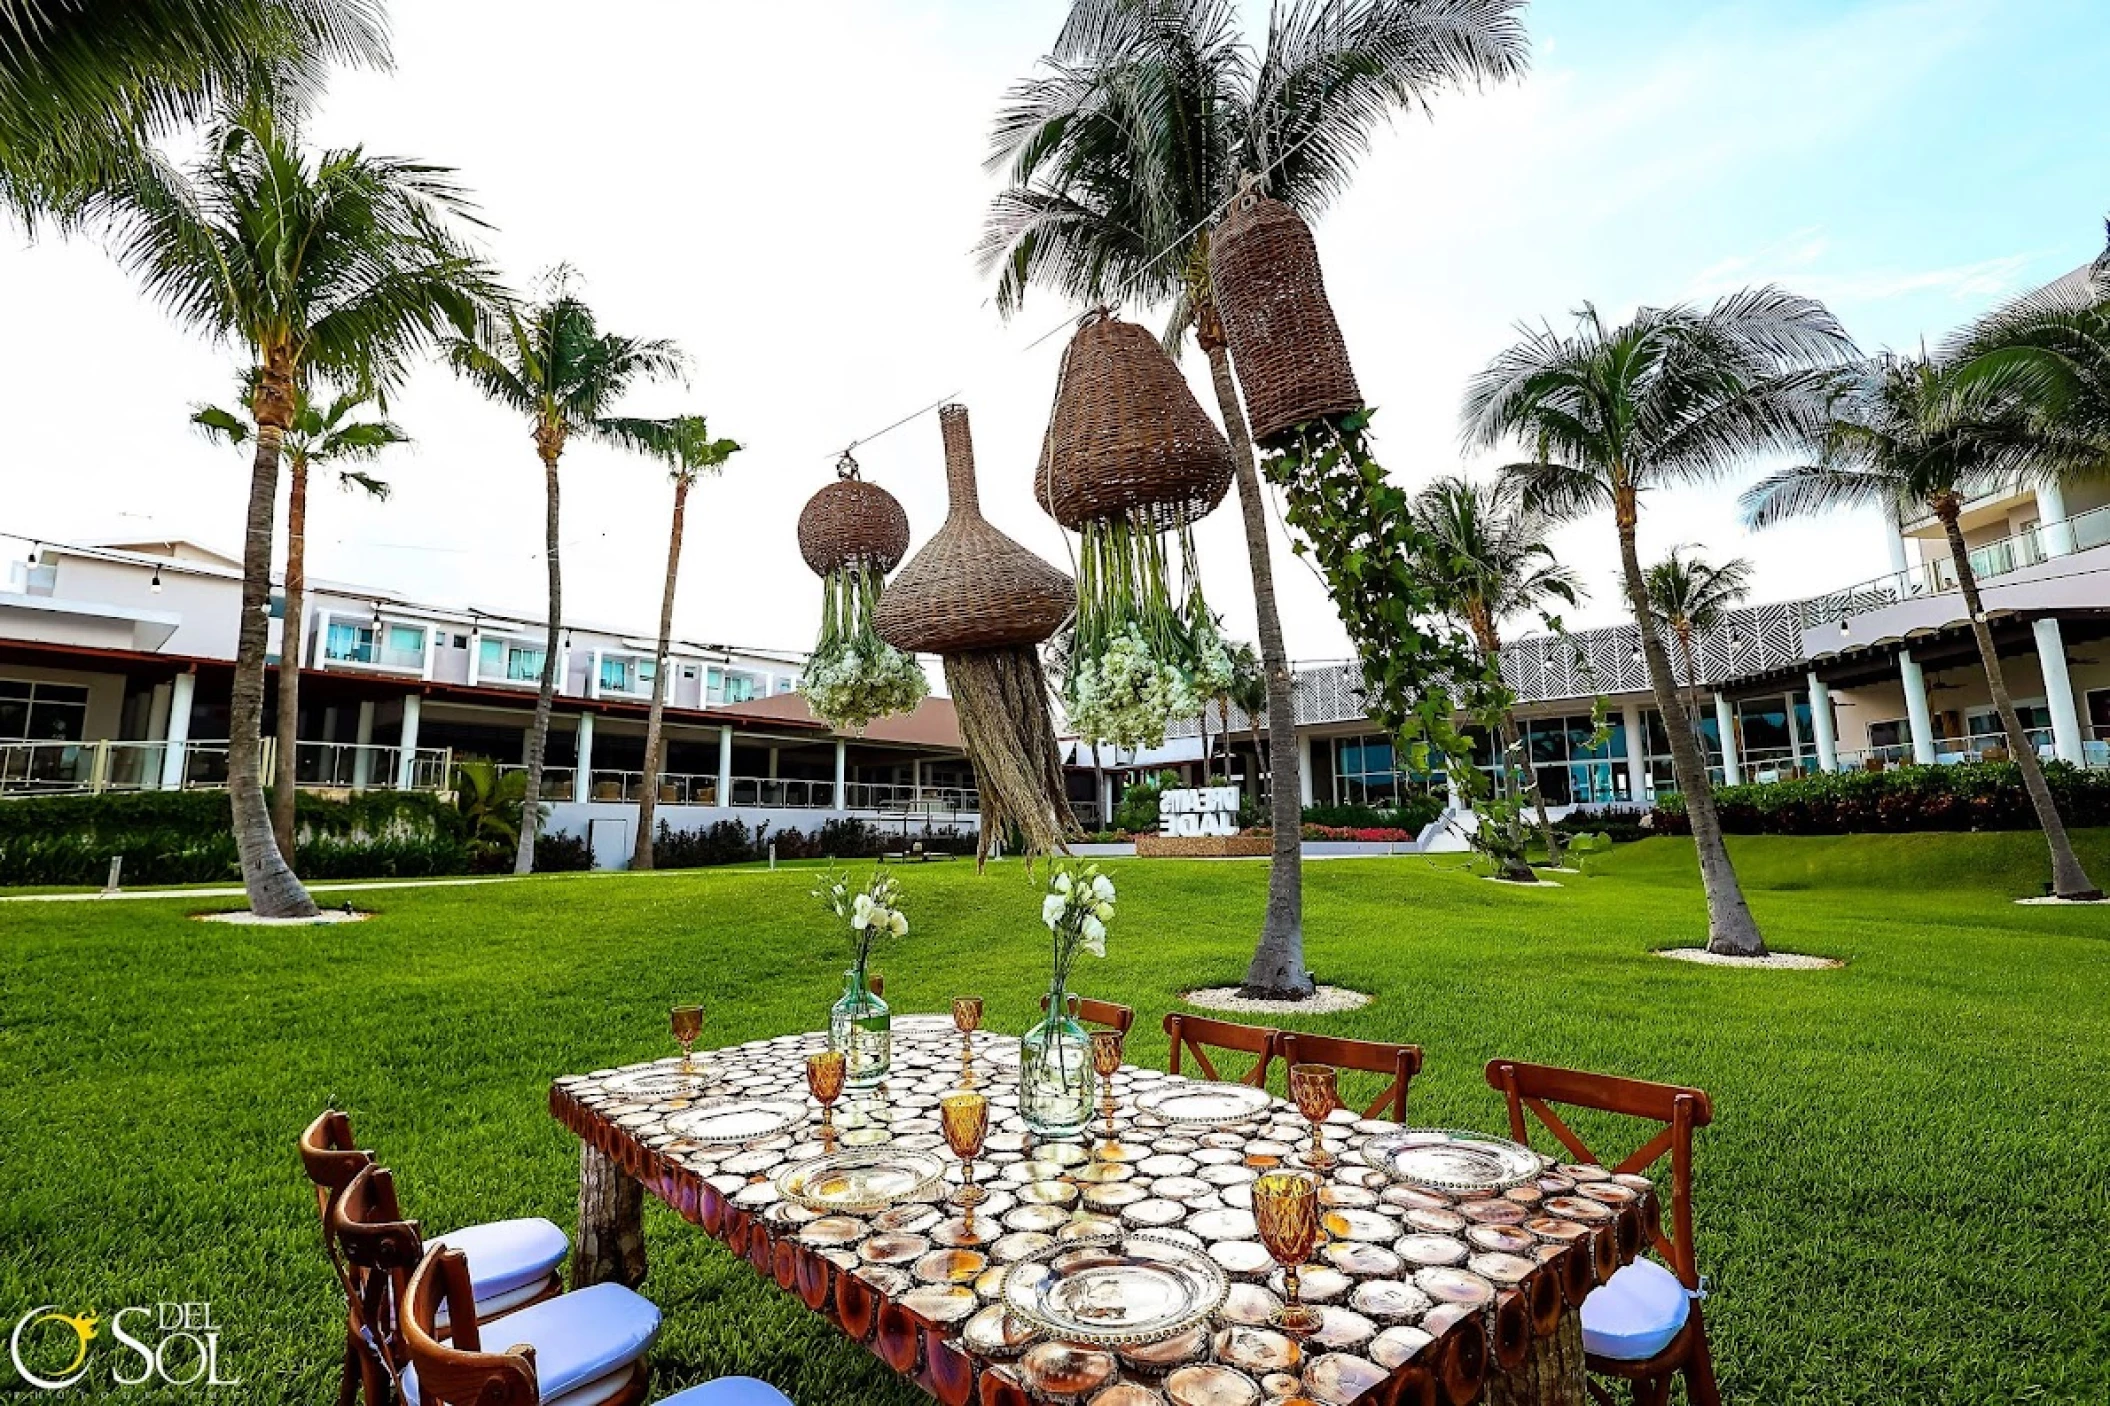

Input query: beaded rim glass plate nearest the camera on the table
[1002,1233,1230,1347]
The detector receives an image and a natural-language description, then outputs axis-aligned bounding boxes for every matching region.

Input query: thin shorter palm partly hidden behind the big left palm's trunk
[190,386,409,863]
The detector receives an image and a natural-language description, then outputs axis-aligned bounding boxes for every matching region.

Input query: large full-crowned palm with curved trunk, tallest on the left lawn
[102,103,496,916]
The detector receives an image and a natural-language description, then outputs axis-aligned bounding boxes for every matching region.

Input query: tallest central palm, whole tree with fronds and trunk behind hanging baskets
[977,0,1526,996]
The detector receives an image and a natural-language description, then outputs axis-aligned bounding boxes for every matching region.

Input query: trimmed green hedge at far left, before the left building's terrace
[0,792,468,887]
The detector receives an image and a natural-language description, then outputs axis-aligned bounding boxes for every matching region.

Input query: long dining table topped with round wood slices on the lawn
[549,1015,1661,1406]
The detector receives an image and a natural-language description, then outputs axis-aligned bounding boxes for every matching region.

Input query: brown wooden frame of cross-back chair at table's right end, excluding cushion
[1488,1060,1722,1406]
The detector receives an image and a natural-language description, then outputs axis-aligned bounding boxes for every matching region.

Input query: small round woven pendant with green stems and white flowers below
[798,452,931,733]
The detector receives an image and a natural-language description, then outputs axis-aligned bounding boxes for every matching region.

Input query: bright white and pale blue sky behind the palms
[0,0,2110,661]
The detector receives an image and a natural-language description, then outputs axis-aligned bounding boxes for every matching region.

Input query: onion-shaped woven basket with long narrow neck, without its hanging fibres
[874,405,1076,654]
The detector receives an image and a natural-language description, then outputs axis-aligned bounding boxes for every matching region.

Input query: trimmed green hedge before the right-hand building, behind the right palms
[1652,762,2110,834]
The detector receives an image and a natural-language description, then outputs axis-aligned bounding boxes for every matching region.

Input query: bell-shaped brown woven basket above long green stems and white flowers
[1034,310,1232,532]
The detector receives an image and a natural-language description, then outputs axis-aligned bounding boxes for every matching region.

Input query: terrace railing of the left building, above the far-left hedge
[0,737,454,796]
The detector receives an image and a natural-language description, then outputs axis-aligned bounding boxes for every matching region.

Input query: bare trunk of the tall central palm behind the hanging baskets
[1196,325,1317,1001]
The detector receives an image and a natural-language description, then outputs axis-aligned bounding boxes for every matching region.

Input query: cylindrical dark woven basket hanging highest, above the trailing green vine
[1209,190,1363,445]
